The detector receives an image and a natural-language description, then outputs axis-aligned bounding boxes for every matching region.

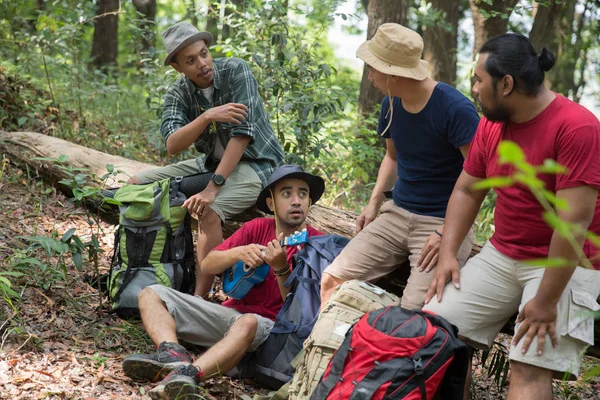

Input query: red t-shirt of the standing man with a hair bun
[464,94,600,269]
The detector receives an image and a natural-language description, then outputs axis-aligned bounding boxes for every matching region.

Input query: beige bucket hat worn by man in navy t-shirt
[356,23,428,81]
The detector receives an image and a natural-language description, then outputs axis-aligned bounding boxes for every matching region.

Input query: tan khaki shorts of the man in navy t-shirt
[324,201,473,310]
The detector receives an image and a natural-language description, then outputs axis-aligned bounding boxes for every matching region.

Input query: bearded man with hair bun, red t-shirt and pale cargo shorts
[424,34,600,400]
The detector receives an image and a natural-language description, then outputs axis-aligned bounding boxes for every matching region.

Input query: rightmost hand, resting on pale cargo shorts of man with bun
[513,297,558,355]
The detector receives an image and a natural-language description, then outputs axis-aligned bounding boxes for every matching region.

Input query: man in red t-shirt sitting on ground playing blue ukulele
[123,165,325,399]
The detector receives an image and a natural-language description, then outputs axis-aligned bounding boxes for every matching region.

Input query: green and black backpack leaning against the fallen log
[108,177,196,318]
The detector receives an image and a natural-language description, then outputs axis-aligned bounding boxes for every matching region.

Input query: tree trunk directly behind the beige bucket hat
[358,0,408,116]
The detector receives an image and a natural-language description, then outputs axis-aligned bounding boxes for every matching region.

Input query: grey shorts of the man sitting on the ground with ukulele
[150,285,273,351]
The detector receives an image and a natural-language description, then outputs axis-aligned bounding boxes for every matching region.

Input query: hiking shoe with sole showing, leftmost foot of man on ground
[123,342,194,382]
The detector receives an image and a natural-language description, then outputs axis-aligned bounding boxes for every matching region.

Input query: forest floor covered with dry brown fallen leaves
[0,155,600,400]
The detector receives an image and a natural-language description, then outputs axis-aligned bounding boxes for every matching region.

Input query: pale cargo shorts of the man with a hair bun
[424,242,600,379]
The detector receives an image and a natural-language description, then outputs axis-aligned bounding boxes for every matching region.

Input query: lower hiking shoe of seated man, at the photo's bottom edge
[148,364,202,400]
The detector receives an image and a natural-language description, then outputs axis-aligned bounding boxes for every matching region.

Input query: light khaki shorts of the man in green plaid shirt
[136,159,262,221]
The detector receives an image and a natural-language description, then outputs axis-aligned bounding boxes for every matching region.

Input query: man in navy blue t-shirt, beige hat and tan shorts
[321,24,479,309]
